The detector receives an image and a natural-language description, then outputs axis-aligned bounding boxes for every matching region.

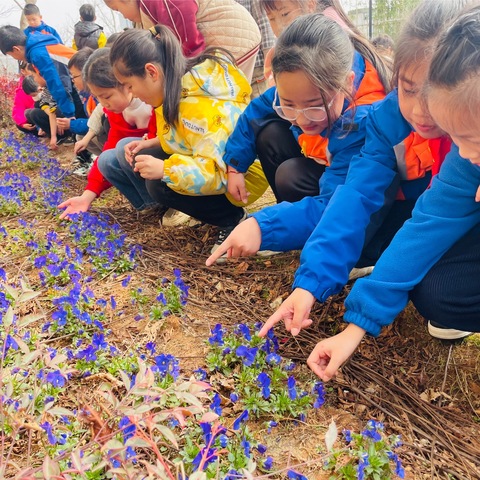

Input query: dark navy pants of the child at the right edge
[410,225,480,332]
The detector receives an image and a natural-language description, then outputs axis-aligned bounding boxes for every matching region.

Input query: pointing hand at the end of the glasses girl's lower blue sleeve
[205,218,262,267]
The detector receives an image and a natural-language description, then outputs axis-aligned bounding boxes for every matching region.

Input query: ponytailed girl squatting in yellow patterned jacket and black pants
[99,25,267,251]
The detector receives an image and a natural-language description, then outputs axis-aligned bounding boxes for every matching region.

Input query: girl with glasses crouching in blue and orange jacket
[224,14,389,206]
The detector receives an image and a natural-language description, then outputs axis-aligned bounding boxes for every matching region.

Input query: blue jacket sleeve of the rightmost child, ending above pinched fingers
[344,146,480,335]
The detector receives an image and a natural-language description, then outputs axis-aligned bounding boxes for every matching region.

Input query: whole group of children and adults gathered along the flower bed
[0,0,480,380]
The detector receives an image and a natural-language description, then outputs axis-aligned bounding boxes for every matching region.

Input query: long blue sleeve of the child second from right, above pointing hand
[293,97,411,301]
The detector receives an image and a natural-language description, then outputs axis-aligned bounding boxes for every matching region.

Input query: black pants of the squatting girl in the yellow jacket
[138,148,244,227]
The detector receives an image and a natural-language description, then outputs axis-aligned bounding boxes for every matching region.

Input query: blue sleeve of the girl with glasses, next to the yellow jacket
[223,87,279,173]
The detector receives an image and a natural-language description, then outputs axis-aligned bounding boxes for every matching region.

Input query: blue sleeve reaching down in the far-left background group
[28,47,75,117]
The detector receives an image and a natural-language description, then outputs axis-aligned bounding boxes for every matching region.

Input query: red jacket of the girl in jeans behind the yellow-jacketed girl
[85,109,157,197]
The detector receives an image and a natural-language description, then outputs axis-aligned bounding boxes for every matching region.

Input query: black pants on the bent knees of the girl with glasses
[256,118,325,202]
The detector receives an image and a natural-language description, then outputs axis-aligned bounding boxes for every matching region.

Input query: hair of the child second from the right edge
[393,0,470,85]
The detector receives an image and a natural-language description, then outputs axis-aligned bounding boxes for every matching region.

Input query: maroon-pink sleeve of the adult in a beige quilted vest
[138,0,205,57]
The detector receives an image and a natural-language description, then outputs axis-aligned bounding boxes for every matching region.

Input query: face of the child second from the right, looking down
[398,63,444,139]
